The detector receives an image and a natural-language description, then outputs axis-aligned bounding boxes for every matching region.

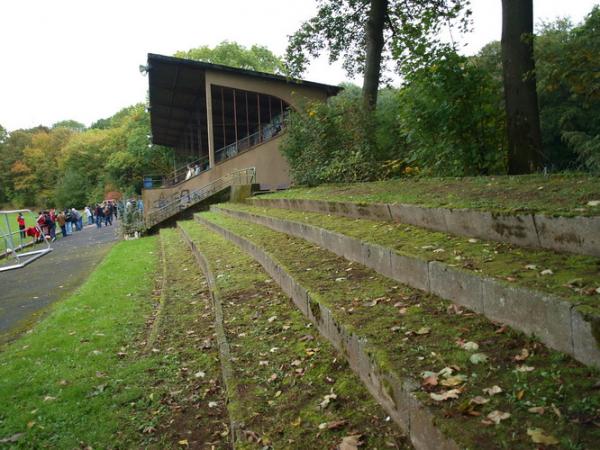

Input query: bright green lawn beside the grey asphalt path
[0,238,158,448]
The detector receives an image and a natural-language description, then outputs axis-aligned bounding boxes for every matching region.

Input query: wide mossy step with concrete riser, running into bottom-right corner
[195,212,600,449]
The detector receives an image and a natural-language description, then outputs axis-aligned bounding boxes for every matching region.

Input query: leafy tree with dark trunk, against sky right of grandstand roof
[286,0,470,109]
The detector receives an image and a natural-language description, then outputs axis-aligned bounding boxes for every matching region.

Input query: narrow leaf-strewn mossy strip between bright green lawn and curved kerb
[152,229,231,449]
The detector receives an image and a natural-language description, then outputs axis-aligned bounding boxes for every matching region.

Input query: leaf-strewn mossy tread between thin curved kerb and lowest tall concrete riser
[179,222,411,449]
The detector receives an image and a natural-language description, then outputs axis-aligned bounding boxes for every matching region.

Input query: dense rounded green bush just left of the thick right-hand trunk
[398,53,507,176]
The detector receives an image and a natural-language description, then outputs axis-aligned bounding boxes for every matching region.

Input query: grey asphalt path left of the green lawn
[0,225,117,343]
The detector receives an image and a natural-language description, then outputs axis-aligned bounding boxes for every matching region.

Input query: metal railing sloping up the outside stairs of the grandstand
[146,167,256,229]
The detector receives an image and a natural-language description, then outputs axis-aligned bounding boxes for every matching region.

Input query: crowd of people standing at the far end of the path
[17,200,118,242]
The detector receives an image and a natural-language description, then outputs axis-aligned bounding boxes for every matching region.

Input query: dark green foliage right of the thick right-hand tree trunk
[536,6,600,173]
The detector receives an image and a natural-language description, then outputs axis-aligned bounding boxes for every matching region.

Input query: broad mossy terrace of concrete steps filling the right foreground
[166,199,600,449]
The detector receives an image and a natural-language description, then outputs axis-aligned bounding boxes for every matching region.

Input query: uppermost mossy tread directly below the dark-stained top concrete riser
[219,203,600,313]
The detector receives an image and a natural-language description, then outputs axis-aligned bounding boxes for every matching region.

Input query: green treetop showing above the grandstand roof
[175,41,284,74]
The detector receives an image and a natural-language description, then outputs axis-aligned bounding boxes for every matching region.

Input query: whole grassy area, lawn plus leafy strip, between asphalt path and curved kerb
[0,232,229,449]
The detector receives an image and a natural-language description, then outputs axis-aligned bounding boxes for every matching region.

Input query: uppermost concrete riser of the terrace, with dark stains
[249,193,600,256]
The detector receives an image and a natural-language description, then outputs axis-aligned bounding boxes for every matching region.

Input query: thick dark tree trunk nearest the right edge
[502,0,542,174]
